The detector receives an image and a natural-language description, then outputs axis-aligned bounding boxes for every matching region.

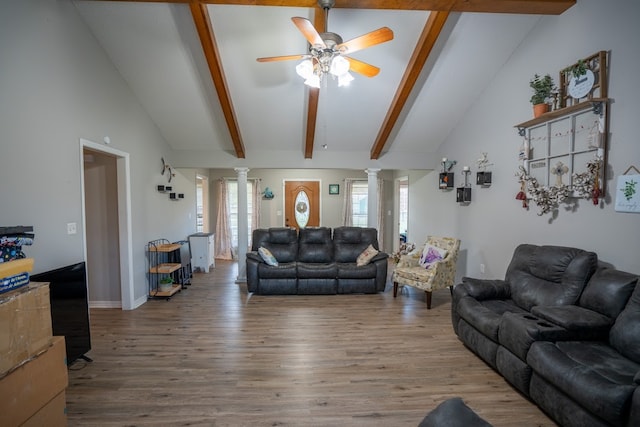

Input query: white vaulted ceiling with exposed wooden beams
[75,0,575,169]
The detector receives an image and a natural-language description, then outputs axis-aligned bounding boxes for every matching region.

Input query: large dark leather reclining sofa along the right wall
[451,244,640,427]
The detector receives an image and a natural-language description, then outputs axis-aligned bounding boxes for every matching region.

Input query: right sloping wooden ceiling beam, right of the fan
[371,12,449,160]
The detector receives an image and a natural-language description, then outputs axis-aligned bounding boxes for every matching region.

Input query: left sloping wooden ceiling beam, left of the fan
[189,2,245,159]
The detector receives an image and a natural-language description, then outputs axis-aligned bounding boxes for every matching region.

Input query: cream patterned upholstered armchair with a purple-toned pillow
[393,236,460,309]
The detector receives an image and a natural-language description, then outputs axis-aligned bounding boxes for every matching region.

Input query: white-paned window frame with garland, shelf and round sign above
[515,51,609,215]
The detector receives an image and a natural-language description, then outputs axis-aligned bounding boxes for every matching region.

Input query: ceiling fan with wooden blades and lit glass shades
[257,0,393,88]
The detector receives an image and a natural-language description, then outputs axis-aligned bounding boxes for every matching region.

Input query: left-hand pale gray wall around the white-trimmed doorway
[0,0,195,306]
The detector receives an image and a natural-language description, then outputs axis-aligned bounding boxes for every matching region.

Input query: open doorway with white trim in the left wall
[80,139,136,310]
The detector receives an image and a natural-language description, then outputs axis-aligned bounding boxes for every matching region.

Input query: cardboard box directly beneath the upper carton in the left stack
[0,337,69,426]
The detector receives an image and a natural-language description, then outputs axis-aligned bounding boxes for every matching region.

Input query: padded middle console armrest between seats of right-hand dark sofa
[531,305,614,340]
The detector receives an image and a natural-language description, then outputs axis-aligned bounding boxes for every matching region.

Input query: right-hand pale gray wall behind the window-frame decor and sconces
[410,0,640,278]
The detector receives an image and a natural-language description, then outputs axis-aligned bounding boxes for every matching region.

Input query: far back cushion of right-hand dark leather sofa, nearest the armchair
[505,244,598,310]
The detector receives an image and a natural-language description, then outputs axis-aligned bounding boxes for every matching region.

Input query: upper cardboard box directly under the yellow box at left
[0,282,53,378]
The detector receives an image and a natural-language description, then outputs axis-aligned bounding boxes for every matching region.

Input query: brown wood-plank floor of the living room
[67,261,555,427]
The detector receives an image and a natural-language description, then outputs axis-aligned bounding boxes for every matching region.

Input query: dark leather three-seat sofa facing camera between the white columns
[247,227,388,295]
